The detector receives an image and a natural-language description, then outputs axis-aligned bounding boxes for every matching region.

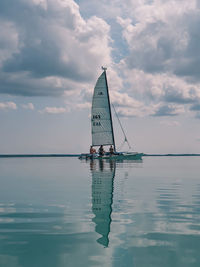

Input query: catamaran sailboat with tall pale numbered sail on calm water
[80,67,143,160]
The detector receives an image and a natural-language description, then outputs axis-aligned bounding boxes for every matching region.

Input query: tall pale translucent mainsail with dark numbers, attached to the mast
[91,68,115,149]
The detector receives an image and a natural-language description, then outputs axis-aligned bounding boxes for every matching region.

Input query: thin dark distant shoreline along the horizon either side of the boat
[0,154,200,158]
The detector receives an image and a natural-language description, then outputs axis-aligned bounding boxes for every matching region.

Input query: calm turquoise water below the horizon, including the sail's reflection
[0,157,200,267]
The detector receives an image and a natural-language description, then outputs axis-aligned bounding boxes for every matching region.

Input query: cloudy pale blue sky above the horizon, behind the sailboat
[0,0,200,154]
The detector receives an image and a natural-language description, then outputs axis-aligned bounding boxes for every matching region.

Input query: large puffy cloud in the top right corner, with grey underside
[117,0,200,81]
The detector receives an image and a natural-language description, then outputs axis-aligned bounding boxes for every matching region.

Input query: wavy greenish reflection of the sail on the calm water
[91,160,115,247]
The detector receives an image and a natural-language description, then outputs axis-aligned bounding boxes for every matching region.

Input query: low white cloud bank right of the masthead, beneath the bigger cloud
[119,65,200,104]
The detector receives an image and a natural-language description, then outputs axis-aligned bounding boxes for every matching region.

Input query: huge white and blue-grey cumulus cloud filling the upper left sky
[0,0,112,95]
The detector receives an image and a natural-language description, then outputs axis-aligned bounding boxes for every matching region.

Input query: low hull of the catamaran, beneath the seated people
[79,152,143,160]
